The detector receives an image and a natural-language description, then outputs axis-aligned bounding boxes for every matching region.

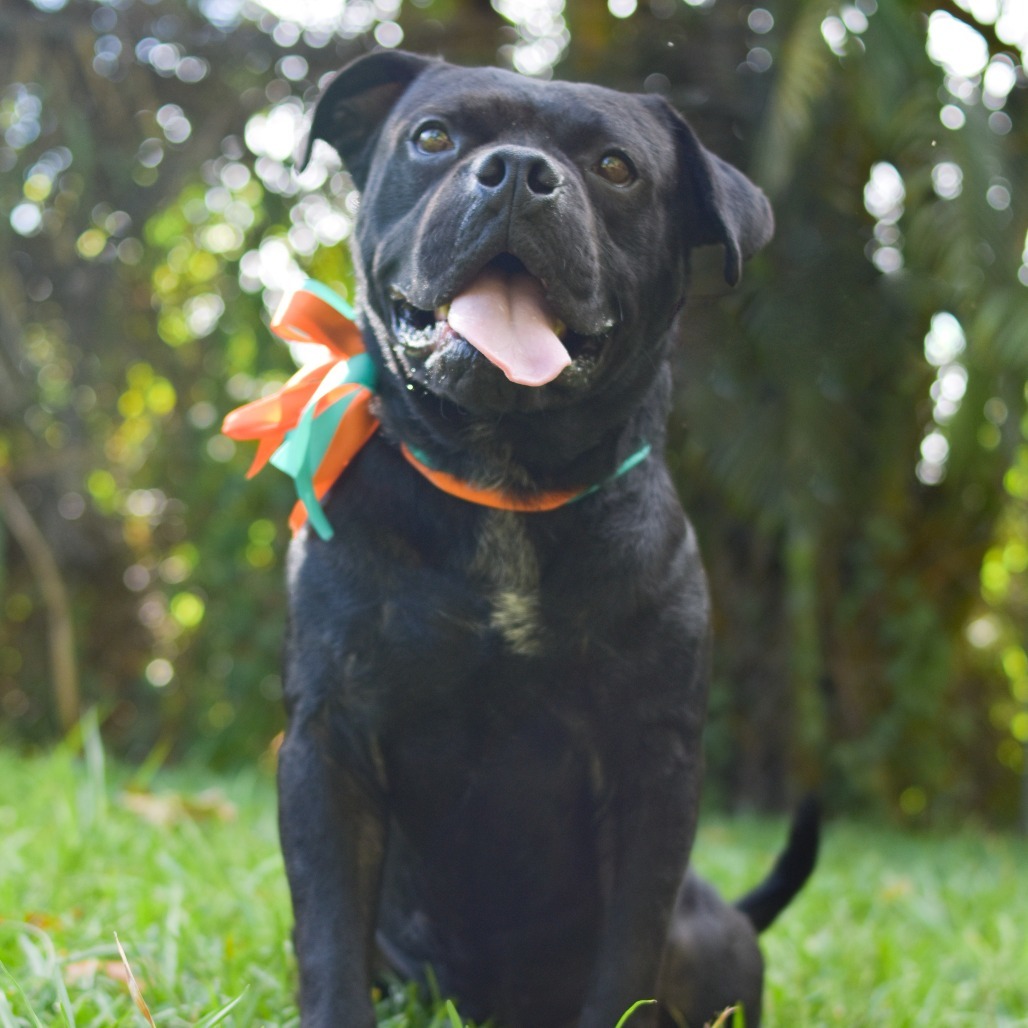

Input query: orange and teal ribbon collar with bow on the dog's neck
[221,279,650,539]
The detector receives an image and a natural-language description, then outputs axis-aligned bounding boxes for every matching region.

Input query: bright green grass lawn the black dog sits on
[0,738,1028,1028]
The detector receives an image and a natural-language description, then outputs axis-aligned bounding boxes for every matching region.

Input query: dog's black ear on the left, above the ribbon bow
[296,50,439,189]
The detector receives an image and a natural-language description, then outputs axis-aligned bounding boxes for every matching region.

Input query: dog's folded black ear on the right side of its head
[660,100,774,286]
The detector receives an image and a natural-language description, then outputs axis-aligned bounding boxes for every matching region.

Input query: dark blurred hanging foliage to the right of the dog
[662,3,1028,819]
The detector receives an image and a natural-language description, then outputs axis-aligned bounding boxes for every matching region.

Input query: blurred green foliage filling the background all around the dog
[0,0,1028,821]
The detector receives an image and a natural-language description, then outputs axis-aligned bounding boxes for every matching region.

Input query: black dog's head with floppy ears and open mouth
[303,51,772,466]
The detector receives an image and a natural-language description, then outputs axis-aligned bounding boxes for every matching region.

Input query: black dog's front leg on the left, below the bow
[279,715,386,1028]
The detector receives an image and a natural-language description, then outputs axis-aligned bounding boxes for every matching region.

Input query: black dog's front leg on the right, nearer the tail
[579,728,700,1028]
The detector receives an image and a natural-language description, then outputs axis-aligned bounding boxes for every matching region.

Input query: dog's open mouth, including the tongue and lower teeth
[393,254,613,388]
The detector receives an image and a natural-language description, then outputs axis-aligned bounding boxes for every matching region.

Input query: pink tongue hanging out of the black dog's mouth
[447,270,572,386]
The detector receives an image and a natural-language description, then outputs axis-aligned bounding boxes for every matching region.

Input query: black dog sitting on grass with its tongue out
[280,52,789,1028]
